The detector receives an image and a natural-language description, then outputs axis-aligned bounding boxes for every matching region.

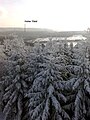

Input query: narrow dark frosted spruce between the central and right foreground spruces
[63,43,81,119]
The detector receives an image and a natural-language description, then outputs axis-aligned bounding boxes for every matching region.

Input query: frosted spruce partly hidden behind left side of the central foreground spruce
[22,43,53,120]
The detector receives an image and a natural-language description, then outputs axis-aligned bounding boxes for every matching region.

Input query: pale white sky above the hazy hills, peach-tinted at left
[0,0,90,31]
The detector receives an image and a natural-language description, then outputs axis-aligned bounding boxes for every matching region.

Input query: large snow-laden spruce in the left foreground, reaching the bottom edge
[2,54,28,120]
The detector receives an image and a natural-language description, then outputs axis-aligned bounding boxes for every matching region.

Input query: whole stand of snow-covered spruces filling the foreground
[0,36,90,120]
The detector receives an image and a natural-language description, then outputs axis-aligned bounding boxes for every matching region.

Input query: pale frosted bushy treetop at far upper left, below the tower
[3,35,28,56]
